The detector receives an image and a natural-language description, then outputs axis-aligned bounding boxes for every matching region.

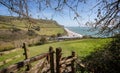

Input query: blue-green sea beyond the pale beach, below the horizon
[66,27,111,38]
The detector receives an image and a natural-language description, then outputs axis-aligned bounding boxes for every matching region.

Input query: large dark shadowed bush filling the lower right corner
[83,37,120,73]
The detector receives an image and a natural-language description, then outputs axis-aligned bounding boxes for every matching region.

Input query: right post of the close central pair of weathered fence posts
[56,48,62,73]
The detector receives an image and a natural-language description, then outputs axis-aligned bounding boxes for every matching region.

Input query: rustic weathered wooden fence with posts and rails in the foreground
[0,43,84,73]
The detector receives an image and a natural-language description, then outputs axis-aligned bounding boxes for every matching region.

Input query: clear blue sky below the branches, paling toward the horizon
[0,0,97,27]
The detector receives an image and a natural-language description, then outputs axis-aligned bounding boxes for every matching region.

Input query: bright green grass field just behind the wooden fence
[0,39,111,69]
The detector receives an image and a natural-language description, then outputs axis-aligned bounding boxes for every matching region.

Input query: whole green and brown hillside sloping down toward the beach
[0,16,65,51]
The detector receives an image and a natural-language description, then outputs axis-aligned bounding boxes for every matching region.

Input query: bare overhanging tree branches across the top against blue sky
[0,0,120,34]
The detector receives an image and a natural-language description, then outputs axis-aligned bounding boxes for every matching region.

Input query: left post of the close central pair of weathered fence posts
[49,47,55,73]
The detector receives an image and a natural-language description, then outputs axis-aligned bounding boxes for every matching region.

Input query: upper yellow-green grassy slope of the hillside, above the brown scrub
[0,16,64,35]
